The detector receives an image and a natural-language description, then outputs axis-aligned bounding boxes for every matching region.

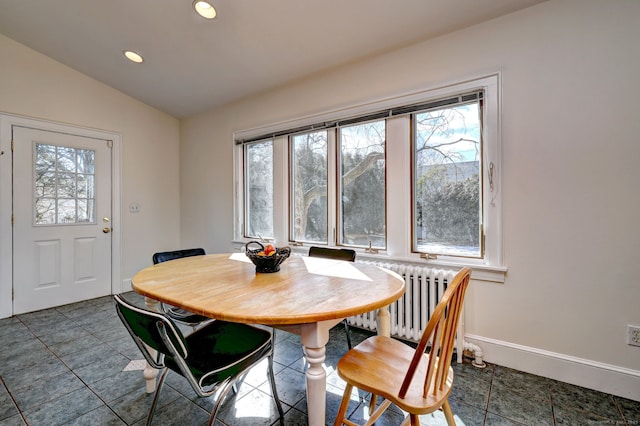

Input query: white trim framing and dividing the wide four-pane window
[233,73,507,282]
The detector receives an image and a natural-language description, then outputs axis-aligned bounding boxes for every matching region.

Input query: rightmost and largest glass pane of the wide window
[413,101,482,257]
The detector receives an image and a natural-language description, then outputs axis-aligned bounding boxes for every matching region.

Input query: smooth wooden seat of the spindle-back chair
[338,336,453,414]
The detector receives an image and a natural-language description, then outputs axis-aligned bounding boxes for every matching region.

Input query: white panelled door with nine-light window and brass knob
[12,126,112,314]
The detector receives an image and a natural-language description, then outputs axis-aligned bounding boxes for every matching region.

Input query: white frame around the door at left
[0,113,122,318]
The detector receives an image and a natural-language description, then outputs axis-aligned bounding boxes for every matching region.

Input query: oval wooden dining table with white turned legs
[131,253,405,426]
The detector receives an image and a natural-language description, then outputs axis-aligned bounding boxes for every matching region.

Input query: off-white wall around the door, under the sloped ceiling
[0,35,180,286]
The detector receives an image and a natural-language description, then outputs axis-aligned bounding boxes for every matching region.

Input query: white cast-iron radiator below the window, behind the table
[348,261,464,362]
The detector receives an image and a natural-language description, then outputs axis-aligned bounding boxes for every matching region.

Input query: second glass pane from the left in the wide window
[291,131,327,243]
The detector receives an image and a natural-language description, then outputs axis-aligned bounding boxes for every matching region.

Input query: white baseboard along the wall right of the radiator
[465,334,640,401]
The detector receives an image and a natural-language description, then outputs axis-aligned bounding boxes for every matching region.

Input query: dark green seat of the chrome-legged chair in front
[165,320,271,388]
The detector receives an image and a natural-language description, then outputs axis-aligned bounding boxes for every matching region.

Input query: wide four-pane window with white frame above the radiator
[234,75,505,281]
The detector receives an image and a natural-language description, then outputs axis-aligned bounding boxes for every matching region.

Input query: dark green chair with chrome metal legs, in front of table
[113,295,283,425]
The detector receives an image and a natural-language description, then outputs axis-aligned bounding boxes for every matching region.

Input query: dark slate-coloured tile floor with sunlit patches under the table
[0,293,640,426]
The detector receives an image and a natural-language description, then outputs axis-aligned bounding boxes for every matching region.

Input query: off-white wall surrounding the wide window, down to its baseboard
[180,0,640,400]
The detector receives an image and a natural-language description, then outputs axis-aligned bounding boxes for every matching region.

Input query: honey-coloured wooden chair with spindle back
[335,268,471,426]
